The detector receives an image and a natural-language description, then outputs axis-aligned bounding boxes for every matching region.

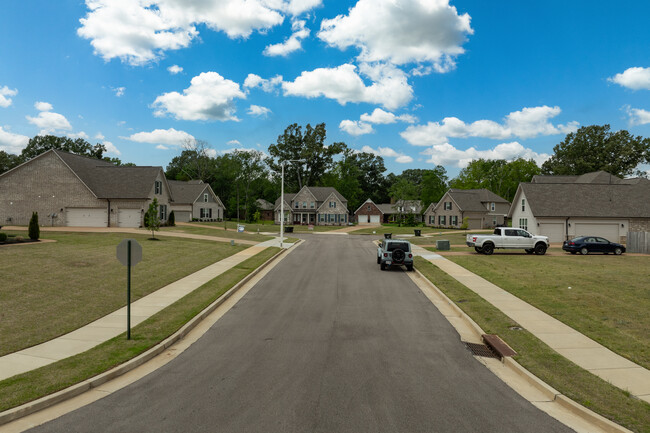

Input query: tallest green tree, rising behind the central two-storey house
[266,123,347,192]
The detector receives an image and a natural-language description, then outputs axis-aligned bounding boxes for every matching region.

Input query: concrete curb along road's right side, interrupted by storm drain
[414,269,632,433]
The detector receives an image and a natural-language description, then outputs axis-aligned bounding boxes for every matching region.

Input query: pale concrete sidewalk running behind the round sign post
[0,239,292,380]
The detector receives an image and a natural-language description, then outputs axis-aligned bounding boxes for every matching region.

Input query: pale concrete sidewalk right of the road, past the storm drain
[413,245,650,403]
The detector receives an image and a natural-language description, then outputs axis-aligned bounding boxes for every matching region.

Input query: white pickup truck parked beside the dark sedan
[466,227,549,256]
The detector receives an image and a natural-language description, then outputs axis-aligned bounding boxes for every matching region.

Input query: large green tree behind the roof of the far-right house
[542,125,650,177]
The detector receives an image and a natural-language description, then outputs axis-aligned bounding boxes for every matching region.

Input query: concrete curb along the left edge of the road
[0,239,303,426]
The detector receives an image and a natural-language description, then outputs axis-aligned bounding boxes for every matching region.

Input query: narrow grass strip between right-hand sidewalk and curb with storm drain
[415,256,650,433]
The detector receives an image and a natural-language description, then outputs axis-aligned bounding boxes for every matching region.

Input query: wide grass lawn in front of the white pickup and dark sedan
[447,254,650,368]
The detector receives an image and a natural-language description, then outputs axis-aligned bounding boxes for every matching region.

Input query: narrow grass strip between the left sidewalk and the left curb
[0,248,280,411]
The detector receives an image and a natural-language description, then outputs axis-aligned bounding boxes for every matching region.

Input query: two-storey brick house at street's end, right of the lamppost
[274,186,348,225]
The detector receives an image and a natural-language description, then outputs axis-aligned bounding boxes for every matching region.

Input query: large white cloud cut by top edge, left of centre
[77,0,321,65]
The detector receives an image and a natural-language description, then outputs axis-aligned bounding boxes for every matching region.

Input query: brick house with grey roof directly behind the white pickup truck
[424,188,510,229]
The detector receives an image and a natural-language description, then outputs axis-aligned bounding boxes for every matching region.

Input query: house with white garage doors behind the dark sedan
[508,171,650,242]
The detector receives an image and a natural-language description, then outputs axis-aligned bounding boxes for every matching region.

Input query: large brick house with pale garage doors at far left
[0,149,172,227]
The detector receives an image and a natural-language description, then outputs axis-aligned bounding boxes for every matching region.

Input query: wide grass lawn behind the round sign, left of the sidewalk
[0,232,246,356]
